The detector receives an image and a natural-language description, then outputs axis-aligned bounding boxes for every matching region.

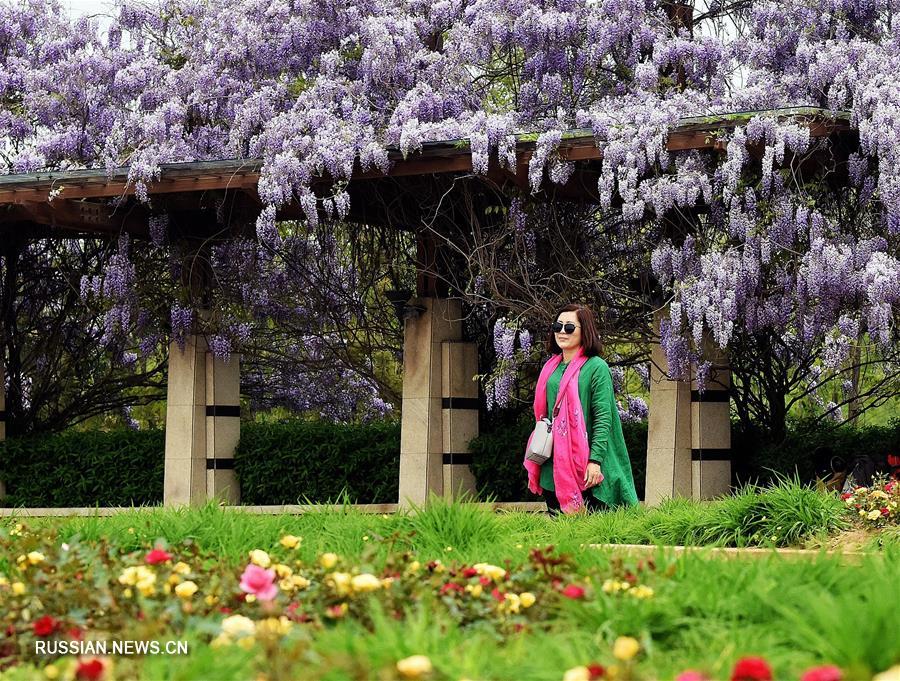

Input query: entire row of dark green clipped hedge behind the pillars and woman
[0,419,900,507]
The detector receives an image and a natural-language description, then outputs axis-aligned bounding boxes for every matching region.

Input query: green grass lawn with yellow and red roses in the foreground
[0,482,900,681]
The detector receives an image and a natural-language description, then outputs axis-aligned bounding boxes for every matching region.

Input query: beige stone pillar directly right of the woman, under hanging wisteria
[644,310,731,506]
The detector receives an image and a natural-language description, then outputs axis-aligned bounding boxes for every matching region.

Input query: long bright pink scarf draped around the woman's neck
[525,349,591,513]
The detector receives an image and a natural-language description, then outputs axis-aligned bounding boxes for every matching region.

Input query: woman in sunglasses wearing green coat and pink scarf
[525,305,638,515]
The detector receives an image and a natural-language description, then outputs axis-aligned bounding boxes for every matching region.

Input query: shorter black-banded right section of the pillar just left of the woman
[441,341,478,497]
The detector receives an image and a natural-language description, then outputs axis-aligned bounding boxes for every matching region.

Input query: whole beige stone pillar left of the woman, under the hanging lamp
[399,297,478,506]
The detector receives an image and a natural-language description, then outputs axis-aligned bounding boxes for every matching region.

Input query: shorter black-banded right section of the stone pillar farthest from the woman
[206,352,241,505]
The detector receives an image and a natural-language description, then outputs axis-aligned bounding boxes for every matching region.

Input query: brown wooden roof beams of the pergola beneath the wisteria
[0,107,853,239]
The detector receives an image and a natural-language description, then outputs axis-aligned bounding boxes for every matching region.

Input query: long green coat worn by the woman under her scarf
[540,357,638,507]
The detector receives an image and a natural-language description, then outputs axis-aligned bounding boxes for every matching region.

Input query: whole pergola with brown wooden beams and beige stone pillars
[0,108,858,504]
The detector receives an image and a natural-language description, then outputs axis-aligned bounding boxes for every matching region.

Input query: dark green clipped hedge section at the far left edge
[0,430,165,507]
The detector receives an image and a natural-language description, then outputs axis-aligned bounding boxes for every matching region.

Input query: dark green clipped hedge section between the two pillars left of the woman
[235,421,400,504]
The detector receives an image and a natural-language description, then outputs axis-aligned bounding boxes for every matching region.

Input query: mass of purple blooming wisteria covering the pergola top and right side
[0,0,900,414]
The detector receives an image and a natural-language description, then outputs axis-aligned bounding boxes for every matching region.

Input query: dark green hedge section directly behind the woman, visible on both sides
[469,419,647,501]
